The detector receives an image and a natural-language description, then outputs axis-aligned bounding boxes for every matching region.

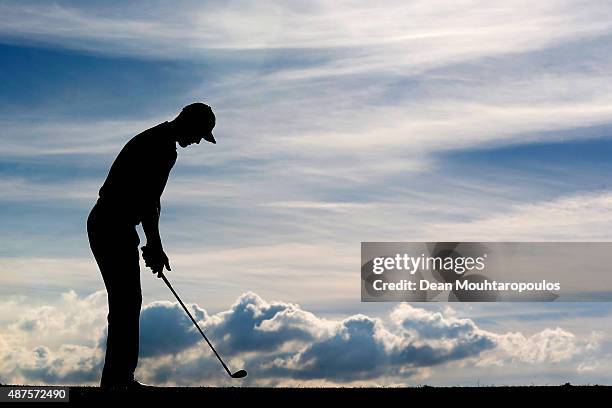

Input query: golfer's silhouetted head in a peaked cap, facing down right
[173,102,217,147]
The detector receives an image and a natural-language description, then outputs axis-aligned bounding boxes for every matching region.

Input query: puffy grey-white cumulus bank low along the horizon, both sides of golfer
[0,292,601,386]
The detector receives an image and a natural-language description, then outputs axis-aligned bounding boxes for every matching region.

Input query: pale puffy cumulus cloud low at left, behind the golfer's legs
[0,291,106,384]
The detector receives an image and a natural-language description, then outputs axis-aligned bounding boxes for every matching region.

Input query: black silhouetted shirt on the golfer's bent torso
[98,122,177,225]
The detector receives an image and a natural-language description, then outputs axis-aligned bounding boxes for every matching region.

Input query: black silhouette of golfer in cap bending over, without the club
[87,103,216,388]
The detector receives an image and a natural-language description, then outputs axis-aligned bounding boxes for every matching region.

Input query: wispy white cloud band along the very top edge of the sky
[0,0,611,64]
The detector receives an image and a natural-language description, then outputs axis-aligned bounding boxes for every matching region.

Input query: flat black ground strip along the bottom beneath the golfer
[0,385,612,408]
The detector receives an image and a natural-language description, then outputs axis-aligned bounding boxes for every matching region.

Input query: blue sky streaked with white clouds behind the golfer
[0,0,612,386]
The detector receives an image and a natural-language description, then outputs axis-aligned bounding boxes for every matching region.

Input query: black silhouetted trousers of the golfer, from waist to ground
[87,203,142,386]
